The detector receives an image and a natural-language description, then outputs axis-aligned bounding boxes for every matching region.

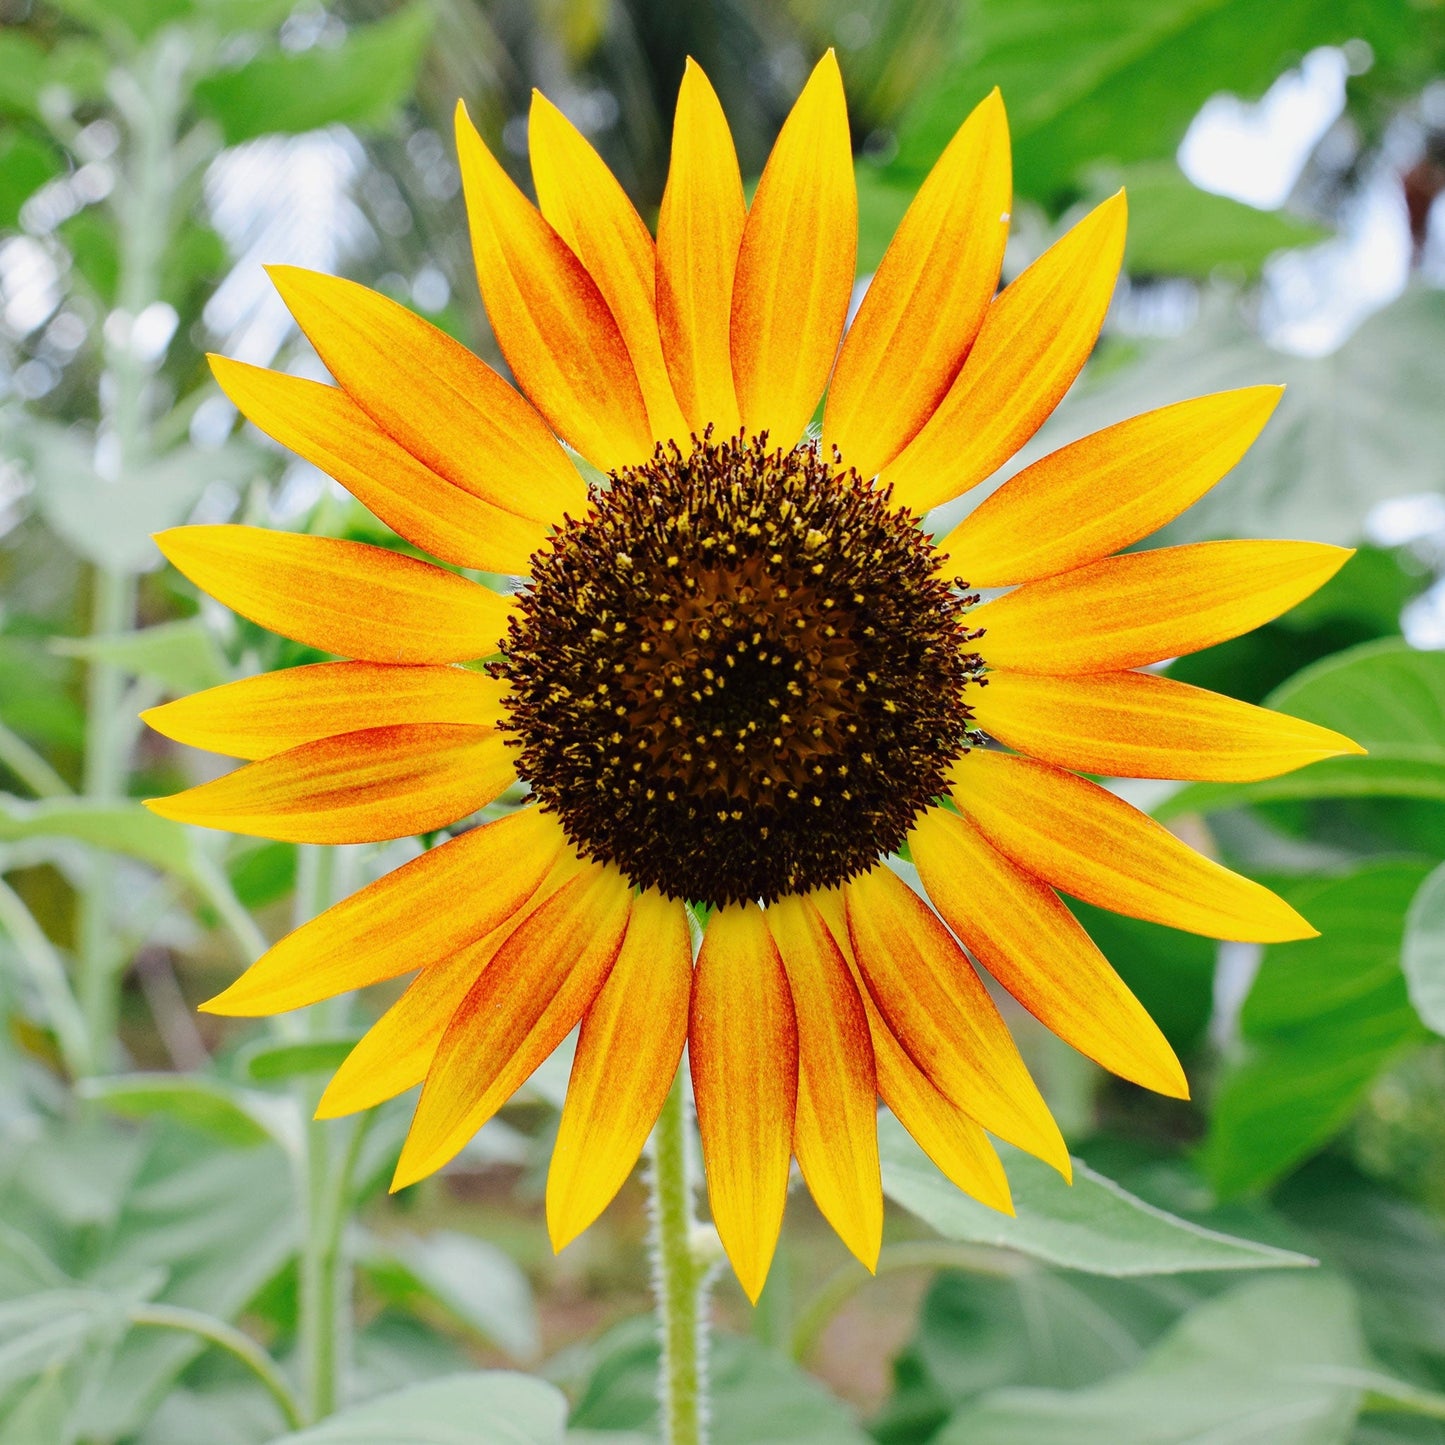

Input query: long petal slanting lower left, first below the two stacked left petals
[201,808,566,1019]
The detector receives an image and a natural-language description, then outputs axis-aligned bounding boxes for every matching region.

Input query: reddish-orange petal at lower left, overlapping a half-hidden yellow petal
[392,863,631,1189]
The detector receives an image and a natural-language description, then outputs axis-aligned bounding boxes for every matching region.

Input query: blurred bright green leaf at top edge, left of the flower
[195,4,432,146]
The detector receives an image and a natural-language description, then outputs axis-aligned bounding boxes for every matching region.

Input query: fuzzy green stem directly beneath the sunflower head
[649,1069,711,1445]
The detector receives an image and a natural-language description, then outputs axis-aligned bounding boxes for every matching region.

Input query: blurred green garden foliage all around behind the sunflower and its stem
[0,0,1445,1445]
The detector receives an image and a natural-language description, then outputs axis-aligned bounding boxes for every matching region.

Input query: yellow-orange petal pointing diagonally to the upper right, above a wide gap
[884,191,1127,513]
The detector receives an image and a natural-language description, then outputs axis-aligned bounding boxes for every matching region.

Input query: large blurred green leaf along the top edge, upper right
[896,0,1418,202]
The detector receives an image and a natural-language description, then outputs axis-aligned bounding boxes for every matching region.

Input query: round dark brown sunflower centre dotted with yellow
[496,438,981,905]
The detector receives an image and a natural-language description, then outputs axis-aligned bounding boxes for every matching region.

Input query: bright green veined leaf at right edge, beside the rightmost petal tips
[1156,637,1445,818]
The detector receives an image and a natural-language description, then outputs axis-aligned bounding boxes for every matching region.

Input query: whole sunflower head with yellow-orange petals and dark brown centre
[146,53,1358,1299]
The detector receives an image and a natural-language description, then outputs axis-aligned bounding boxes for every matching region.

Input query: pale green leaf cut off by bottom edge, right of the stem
[936,1276,1368,1445]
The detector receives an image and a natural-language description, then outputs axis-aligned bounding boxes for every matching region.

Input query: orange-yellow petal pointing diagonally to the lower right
[909,808,1189,1098]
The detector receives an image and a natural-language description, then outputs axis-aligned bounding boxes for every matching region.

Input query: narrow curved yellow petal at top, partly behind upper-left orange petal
[527,91,688,442]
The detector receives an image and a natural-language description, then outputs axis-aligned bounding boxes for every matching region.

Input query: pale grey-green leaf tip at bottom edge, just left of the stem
[275,1370,566,1445]
